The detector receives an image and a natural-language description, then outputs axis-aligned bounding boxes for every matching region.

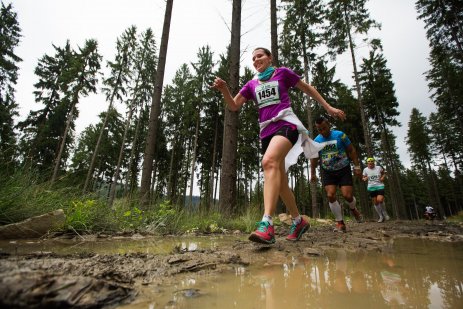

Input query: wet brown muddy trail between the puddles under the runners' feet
[0,220,463,308]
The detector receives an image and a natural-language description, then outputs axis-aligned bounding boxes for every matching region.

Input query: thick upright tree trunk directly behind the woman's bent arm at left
[219,0,241,213]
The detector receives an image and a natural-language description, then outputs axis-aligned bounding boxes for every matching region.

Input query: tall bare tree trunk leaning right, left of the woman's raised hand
[140,0,174,206]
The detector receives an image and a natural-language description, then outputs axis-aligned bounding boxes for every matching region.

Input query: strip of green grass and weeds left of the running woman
[0,168,272,234]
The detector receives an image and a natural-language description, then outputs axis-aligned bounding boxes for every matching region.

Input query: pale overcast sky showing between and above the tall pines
[9,0,436,167]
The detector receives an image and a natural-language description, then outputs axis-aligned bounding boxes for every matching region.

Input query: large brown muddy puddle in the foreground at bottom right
[124,239,463,309]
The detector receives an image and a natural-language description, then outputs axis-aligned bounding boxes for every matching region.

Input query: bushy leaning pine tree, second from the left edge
[18,40,101,177]
